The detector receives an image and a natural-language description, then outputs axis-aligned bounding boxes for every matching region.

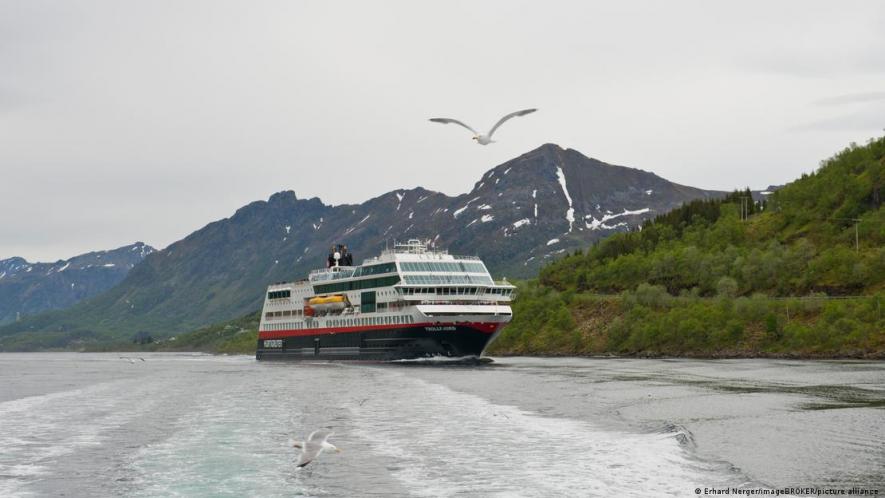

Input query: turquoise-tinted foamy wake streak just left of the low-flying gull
[127,392,309,497]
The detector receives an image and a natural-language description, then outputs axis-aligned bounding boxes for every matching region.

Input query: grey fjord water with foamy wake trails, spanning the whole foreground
[0,353,885,497]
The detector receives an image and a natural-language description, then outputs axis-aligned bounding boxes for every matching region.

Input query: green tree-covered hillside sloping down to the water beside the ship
[492,138,885,357]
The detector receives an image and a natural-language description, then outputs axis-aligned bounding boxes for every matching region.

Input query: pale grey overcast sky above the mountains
[0,0,885,261]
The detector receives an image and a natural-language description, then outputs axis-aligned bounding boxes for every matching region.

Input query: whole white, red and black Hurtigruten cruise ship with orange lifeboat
[256,239,515,361]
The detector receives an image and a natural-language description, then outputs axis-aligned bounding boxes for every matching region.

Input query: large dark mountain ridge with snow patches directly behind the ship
[0,144,724,349]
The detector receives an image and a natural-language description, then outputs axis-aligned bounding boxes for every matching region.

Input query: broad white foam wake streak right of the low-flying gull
[349,367,725,497]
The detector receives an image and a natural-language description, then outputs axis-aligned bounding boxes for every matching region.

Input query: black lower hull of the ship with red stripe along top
[255,322,505,362]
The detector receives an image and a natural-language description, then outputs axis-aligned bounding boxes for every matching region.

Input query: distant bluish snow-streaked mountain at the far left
[0,242,154,323]
